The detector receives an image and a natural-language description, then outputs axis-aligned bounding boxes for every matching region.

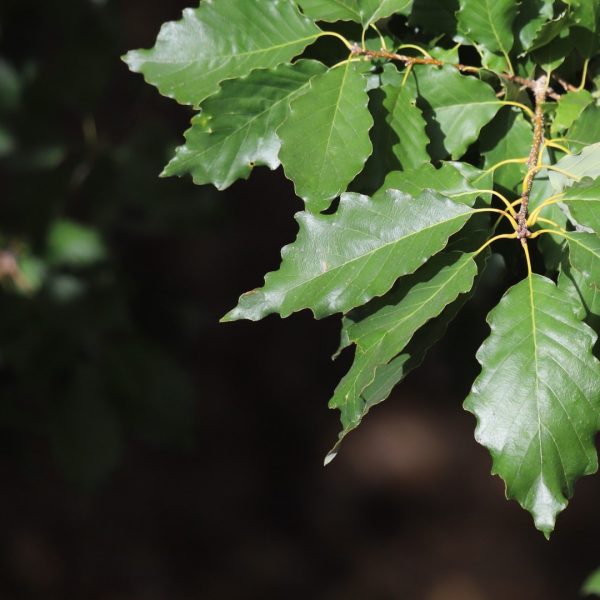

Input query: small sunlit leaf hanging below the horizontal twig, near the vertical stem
[413,66,501,160]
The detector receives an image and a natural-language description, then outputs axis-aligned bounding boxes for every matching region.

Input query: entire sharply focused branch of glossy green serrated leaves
[125,0,600,536]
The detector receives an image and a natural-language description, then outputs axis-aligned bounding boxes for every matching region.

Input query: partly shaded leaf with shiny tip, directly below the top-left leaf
[163,60,326,190]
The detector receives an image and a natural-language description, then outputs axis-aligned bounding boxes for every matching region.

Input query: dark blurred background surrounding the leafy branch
[0,0,600,600]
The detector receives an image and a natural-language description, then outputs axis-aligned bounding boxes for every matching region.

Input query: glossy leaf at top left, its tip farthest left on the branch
[124,0,321,106]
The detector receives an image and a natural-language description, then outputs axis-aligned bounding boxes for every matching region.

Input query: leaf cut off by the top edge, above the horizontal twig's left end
[298,0,412,28]
